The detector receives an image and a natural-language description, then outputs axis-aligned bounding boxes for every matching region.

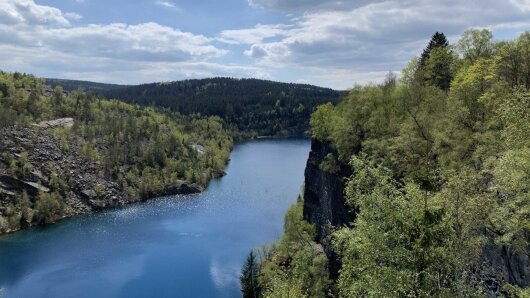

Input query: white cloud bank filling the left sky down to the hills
[0,0,233,84]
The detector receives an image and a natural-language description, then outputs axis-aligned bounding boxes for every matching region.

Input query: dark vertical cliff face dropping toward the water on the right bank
[304,139,354,277]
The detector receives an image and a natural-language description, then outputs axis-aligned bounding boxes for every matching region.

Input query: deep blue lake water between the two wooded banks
[0,139,309,297]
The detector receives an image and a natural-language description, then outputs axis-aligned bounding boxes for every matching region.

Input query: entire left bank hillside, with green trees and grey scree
[0,72,232,233]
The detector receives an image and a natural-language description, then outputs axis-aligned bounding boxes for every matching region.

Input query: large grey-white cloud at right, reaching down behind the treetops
[237,0,530,88]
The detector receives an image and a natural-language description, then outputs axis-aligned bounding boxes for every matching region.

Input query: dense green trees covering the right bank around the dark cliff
[241,29,530,297]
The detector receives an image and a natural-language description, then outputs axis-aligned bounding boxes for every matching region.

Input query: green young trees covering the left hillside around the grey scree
[0,73,231,207]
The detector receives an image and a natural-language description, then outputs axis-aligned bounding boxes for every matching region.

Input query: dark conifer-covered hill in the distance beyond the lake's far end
[105,78,344,137]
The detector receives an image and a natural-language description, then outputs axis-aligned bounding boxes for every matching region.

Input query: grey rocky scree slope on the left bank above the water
[0,126,202,234]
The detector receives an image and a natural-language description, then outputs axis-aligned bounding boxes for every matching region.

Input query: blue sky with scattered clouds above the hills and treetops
[0,0,530,90]
